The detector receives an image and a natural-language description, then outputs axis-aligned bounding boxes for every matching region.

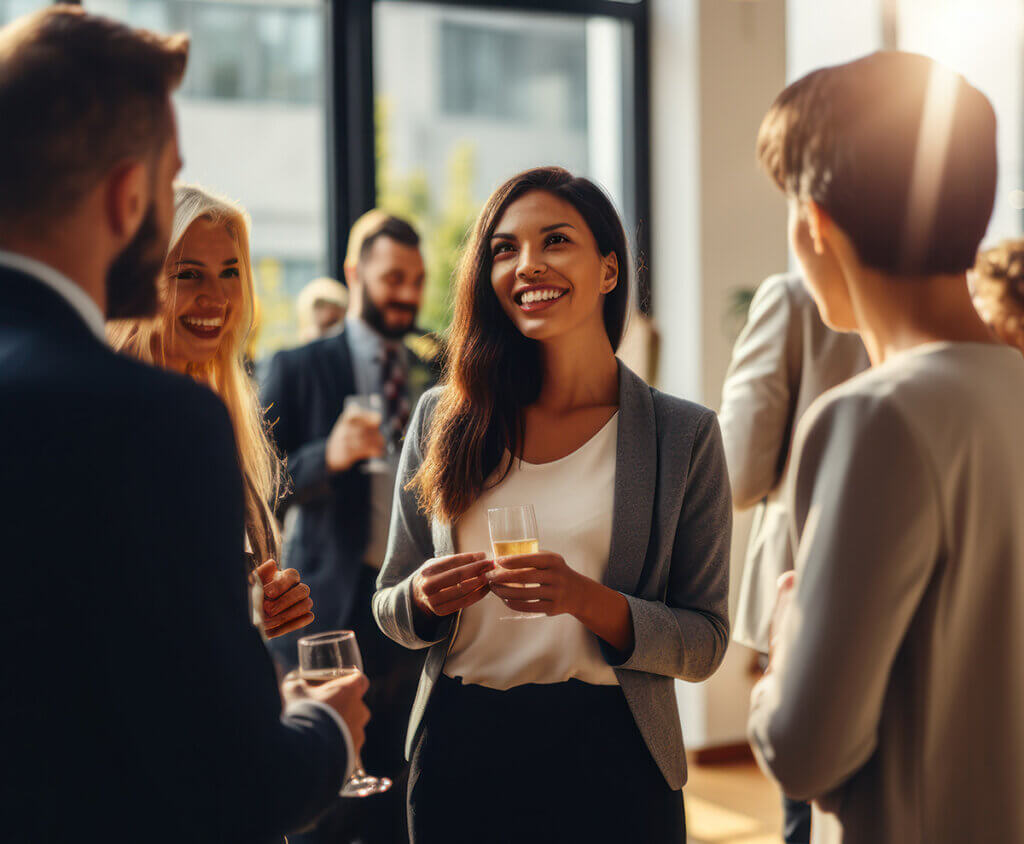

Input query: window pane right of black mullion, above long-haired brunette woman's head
[374,0,637,329]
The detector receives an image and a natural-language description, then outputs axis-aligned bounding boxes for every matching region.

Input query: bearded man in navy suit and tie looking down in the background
[262,210,436,842]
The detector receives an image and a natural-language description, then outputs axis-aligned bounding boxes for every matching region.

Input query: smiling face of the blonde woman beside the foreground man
[161,217,245,371]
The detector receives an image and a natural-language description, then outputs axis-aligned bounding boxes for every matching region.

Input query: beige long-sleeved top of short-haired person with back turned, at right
[749,343,1024,844]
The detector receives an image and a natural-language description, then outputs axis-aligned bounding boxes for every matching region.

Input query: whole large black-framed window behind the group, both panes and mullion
[0,0,648,357]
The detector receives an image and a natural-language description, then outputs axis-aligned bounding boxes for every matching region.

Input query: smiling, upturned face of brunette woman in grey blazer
[490,191,618,341]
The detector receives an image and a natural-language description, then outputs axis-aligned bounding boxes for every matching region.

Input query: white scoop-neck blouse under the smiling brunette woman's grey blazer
[444,413,618,689]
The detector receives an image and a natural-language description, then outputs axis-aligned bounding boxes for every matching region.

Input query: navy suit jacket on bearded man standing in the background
[261,332,436,664]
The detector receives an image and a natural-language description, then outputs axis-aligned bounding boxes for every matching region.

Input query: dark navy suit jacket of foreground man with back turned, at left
[0,267,345,842]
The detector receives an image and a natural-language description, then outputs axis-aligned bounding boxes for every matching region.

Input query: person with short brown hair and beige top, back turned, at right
[748,52,1024,844]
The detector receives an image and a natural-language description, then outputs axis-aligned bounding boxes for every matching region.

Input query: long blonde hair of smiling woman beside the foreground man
[106,184,283,564]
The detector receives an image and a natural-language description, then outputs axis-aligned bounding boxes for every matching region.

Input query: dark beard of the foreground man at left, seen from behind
[106,204,167,320]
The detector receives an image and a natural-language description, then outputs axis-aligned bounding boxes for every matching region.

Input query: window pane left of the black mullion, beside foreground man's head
[89,0,327,358]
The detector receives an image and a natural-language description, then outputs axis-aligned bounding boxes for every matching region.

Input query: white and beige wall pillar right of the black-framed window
[650,0,786,749]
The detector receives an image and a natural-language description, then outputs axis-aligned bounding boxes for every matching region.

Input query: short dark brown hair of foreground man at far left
[0,5,188,225]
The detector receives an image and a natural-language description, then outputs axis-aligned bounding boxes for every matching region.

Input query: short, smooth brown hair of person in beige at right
[757,51,996,275]
